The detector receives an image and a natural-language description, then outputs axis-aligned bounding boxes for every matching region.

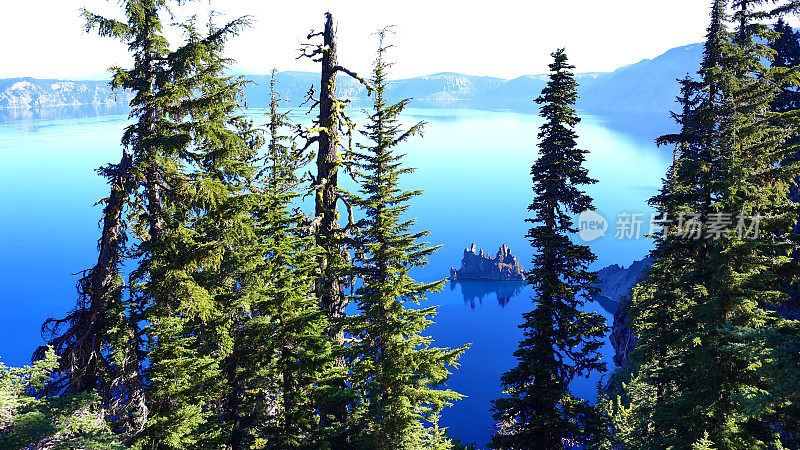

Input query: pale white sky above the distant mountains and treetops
[0,0,788,78]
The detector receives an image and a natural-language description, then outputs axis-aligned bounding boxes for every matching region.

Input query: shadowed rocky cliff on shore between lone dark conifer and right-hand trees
[595,256,653,367]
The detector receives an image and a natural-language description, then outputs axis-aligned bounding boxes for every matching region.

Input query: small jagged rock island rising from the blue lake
[450,244,525,281]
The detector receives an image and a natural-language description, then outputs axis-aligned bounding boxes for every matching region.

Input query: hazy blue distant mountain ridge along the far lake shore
[0,44,702,113]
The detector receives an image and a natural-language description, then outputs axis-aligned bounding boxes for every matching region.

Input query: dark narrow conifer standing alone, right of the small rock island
[491,49,607,449]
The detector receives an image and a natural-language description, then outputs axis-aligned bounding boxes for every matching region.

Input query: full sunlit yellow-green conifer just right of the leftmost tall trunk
[132,15,268,448]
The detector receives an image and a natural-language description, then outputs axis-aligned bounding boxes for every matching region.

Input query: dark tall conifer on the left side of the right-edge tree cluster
[625,0,730,448]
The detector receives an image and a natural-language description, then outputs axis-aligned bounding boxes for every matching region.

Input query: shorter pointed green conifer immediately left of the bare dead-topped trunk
[231,72,333,449]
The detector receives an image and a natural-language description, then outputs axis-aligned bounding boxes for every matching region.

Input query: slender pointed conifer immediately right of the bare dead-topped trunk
[347,29,466,449]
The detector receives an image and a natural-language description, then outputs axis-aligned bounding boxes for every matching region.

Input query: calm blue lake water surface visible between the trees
[0,105,674,448]
